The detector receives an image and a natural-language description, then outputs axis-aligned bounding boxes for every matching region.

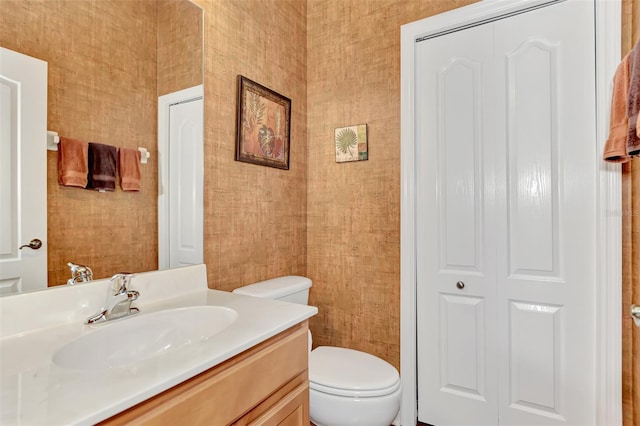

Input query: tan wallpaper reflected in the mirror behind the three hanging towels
[0,0,158,285]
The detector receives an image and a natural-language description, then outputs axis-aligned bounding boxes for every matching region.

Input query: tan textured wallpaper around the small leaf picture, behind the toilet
[307,0,478,367]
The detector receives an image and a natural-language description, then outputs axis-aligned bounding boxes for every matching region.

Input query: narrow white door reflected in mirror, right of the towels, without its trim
[169,98,204,268]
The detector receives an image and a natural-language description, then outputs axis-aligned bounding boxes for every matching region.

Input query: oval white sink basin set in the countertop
[53,306,238,370]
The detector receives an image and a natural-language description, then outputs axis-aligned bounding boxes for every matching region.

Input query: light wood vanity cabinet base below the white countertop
[101,321,309,426]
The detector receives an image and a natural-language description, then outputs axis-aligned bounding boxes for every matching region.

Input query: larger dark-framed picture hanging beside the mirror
[236,75,291,170]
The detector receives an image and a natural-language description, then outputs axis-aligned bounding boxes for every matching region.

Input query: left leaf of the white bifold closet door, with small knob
[416,25,498,426]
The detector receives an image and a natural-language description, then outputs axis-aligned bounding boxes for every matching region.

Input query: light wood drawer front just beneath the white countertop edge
[103,321,308,425]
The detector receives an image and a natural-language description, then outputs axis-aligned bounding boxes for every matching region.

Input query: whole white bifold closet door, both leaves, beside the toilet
[416,0,597,426]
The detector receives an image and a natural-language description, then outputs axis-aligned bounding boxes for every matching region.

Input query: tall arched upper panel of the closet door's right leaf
[504,39,559,277]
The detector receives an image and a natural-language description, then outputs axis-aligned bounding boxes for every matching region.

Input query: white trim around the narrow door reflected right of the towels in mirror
[158,84,204,269]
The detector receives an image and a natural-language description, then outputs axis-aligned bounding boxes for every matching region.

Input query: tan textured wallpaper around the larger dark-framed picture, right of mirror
[196,0,307,290]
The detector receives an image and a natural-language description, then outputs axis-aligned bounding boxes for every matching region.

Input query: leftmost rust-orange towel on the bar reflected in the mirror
[58,137,89,188]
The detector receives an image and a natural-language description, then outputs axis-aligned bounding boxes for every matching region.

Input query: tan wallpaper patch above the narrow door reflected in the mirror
[157,0,203,96]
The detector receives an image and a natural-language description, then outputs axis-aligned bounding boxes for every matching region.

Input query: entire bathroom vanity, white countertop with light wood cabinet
[0,265,317,426]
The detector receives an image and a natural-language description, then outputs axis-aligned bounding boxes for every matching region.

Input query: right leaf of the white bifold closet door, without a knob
[495,0,598,426]
